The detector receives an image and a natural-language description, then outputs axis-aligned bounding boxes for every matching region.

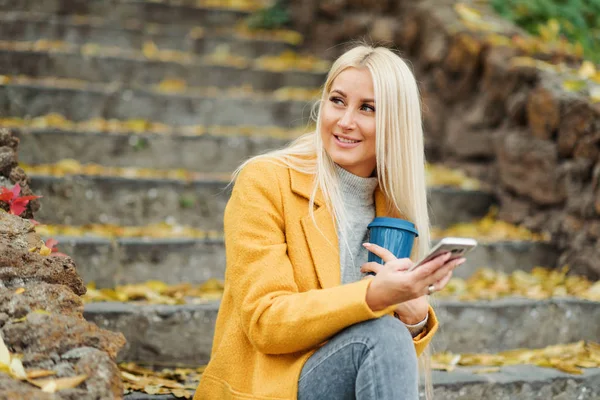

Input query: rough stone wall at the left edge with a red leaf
[0,129,125,400]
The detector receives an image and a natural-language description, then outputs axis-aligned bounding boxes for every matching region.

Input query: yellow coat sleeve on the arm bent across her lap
[224,162,430,354]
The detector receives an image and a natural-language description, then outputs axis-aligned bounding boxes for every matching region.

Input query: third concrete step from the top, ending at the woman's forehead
[0,48,326,91]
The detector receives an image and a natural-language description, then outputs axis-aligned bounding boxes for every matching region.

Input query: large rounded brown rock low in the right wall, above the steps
[497,132,567,205]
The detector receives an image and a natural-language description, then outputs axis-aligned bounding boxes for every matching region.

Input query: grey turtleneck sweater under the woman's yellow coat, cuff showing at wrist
[336,164,427,336]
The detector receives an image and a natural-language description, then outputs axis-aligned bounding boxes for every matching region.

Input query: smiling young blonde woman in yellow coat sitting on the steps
[194,46,464,400]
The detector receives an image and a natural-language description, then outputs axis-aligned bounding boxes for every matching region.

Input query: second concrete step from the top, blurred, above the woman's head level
[0,12,296,58]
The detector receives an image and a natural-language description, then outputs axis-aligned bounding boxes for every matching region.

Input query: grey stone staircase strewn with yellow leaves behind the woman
[0,0,600,400]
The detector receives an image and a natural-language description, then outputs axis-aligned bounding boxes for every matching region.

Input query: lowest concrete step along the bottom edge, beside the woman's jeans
[125,365,600,400]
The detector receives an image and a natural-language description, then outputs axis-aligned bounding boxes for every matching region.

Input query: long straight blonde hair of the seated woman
[233,45,433,399]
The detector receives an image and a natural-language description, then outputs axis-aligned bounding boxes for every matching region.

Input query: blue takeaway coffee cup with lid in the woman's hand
[368,217,419,264]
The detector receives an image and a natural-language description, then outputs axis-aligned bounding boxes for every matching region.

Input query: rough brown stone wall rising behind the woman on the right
[291,0,600,279]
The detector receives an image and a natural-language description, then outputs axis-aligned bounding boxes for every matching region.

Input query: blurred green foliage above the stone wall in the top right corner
[490,0,600,63]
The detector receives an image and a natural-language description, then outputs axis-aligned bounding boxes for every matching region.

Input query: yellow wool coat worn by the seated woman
[194,161,437,400]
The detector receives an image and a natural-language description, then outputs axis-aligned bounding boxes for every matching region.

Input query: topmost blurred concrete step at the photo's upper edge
[0,0,255,27]
